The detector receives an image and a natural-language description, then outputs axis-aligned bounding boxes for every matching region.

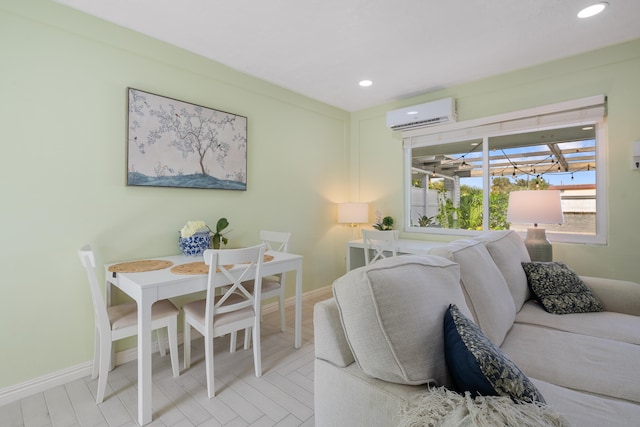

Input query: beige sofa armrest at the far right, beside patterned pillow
[580,276,640,316]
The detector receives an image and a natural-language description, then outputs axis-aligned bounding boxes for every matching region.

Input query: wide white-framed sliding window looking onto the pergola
[403,96,606,243]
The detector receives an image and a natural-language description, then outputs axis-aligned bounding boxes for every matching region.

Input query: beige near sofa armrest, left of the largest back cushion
[313,298,355,368]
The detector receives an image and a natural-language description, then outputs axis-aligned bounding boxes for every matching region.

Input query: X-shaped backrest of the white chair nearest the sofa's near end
[204,244,265,325]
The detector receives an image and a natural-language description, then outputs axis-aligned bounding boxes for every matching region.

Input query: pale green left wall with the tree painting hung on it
[0,0,350,389]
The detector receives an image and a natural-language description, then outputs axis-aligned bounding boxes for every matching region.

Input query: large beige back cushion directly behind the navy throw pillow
[333,255,471,385]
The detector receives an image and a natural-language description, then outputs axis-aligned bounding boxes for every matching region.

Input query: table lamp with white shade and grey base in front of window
[507,190,564,261]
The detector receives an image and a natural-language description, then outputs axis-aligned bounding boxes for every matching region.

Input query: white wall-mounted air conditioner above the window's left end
[387,98,456,130]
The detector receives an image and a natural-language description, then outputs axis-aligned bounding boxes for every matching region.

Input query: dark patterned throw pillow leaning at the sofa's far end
[522,262,604,314]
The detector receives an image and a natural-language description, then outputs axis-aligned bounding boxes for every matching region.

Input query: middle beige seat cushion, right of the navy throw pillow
[501,323,640,403]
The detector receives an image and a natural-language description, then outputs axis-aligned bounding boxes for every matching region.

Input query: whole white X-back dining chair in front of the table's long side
[182,244,265,398]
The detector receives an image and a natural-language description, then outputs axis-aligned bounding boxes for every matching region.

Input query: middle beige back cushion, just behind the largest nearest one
[431,240,516,346]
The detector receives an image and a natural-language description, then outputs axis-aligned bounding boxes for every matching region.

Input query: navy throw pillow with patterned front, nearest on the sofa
[444,304,545,403]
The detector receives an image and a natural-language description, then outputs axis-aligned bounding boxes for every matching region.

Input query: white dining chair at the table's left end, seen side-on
[78,245,180,403]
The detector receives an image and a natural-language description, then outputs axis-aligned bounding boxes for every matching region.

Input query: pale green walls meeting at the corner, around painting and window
[0,0,640,389]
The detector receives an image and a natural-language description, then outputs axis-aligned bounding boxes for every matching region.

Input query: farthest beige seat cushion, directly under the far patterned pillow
[516,300,640,345]
